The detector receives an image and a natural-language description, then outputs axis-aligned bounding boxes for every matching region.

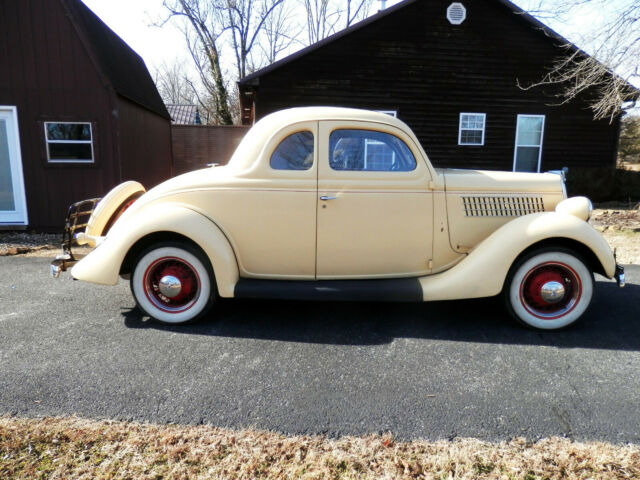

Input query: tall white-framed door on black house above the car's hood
[513,115,544,172]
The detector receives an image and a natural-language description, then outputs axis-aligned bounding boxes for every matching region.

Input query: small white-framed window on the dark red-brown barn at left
[44,122,93,163]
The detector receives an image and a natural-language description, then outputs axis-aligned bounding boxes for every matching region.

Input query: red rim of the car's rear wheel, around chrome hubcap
[143,257,200,313]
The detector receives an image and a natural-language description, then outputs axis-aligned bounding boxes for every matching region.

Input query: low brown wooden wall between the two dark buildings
[171,125,249,175]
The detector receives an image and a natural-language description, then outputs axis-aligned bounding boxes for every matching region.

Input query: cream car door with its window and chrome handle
[316,121,433,279]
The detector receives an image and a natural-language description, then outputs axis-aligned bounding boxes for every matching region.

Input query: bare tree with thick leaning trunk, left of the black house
[162,0,233,125]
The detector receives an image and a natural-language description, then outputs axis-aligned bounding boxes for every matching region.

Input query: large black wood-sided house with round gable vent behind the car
[239,0,620,175]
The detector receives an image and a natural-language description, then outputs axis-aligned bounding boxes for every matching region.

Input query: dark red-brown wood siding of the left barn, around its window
[0,0,171,230]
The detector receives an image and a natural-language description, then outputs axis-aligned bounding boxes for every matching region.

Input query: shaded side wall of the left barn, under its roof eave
[117,97,172,189]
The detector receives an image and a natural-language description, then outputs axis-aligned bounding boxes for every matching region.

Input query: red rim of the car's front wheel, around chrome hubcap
[520,262,582,320]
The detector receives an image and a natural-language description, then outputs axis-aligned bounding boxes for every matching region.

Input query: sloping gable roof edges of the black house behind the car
[238,0,600,86]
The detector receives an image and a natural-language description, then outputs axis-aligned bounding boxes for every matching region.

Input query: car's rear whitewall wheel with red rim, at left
[131,243,216,324]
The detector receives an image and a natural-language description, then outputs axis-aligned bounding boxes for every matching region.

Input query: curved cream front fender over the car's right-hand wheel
[420,212,616,301]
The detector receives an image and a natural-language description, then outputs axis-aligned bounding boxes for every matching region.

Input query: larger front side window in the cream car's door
[329,130,416,172]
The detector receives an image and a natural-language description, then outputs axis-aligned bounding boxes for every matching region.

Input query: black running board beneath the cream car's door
[234,278,423,302]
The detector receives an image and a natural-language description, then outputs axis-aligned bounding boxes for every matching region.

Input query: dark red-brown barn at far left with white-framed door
[0,0,172,230]
